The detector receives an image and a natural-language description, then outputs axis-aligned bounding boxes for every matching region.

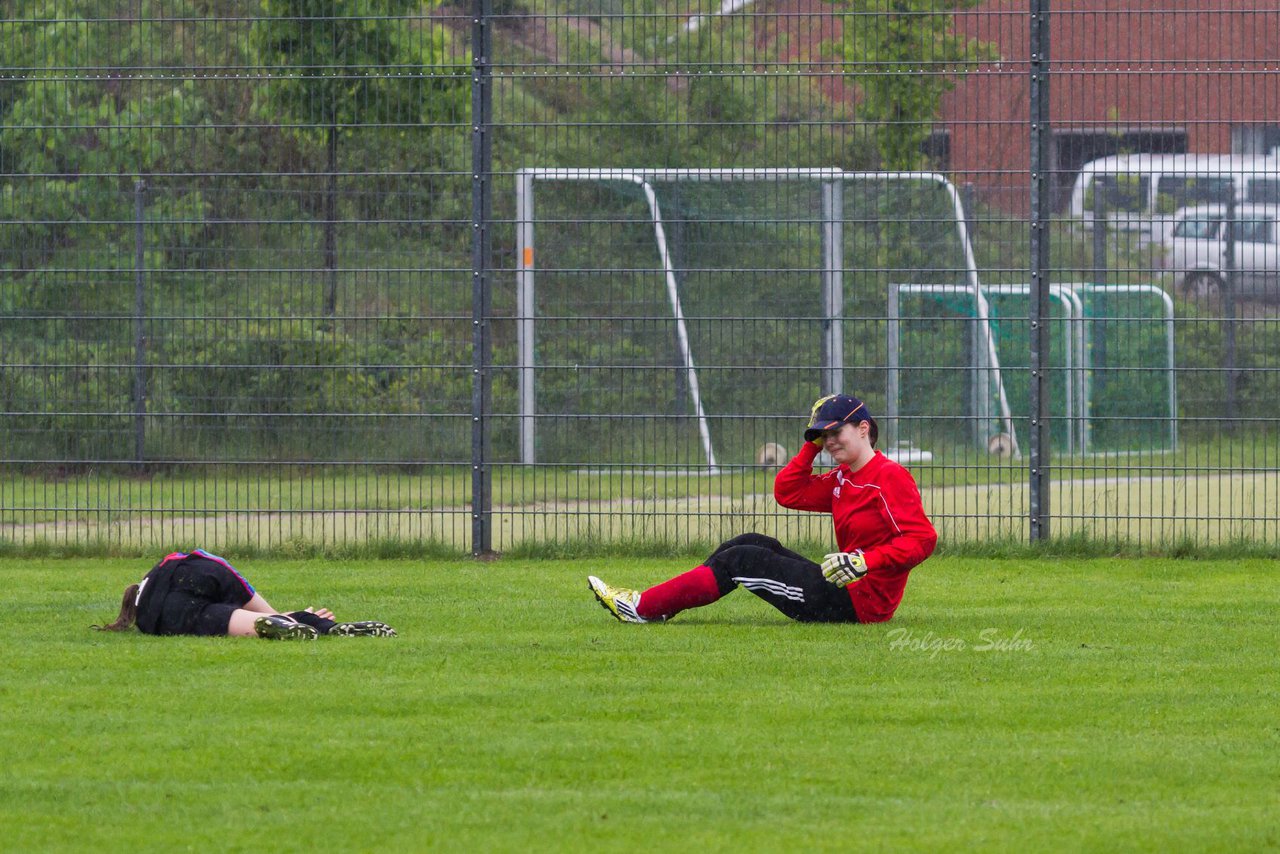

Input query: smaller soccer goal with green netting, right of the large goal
[887,283,1178,456]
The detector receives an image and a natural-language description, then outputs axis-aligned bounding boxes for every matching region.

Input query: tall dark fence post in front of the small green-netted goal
[1028,0,1050,542]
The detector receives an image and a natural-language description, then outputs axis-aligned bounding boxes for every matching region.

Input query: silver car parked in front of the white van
[1165,205,1280,301]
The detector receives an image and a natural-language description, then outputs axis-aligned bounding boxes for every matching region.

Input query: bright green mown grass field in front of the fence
[0,557,1280,851]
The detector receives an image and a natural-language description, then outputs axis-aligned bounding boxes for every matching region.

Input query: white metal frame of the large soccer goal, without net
[516,168,983,474]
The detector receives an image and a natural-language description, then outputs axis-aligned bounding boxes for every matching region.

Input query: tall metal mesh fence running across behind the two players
[0,0,1280,552]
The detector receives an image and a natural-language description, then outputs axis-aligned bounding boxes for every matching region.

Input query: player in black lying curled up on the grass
[93,548,396,640]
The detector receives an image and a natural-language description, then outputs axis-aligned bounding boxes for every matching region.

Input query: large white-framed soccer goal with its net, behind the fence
[516,169,978,474]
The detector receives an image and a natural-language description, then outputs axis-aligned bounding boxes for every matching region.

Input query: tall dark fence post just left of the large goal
[471,0,493,556]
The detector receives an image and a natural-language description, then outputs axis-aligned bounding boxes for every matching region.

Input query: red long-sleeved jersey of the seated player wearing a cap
[773,442,938,622]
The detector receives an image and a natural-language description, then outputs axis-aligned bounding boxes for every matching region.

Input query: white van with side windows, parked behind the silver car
[1069,154,1280,241]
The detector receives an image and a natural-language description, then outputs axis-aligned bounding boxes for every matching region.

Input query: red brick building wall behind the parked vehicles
[753,0,1280,211]
